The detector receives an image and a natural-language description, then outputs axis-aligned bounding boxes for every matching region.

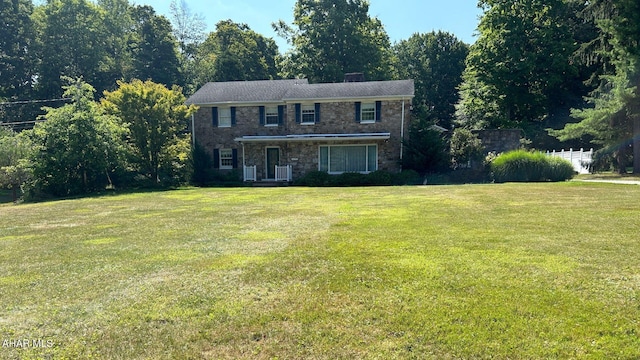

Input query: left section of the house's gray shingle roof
[187,79,308,105]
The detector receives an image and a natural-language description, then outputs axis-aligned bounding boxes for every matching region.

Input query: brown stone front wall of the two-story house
[193,98,411,180]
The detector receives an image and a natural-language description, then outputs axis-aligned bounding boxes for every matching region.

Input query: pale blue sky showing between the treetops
[134,0,481,52]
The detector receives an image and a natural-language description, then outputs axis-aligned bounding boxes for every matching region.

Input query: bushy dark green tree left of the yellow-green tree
[31,78,122,196]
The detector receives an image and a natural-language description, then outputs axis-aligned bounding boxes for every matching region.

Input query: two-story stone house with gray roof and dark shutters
[187,79,414,181]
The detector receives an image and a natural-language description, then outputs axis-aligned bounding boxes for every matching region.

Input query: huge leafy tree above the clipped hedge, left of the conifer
[457,0,577,128]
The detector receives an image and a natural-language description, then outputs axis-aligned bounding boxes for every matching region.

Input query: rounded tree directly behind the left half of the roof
[198,20,278,85]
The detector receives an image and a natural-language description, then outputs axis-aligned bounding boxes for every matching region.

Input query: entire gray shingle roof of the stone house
[187,79,414,105]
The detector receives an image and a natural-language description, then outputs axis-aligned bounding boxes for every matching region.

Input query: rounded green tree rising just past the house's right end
[393,31,469,129]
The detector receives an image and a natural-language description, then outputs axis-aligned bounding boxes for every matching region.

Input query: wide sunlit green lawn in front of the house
[0,182,640,359]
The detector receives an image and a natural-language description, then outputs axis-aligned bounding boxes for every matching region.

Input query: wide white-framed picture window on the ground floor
[318,145,378,174]
